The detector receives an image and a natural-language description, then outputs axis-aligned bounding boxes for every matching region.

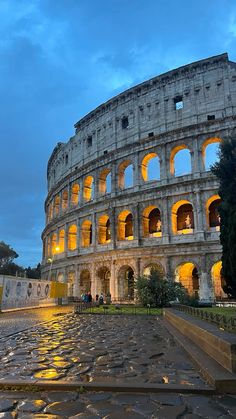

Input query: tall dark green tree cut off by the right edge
[211,136,236,298]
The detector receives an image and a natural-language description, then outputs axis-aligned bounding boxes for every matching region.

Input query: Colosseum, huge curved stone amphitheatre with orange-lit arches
[42,53,236,301]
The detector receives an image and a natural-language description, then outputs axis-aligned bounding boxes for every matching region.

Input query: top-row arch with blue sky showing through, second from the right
[170,144,192,177]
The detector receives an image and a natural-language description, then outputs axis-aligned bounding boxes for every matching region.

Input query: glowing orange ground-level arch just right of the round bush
[175,262,199,298]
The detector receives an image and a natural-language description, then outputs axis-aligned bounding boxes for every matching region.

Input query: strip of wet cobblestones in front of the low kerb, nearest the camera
[0,391,236,419]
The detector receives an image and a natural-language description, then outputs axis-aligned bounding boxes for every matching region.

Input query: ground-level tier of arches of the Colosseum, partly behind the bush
[42,244,226,301]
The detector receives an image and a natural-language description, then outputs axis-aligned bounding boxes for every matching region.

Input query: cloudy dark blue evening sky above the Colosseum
[0,0,236,266]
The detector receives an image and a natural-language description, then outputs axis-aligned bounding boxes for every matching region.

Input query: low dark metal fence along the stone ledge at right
[173,304,236,333]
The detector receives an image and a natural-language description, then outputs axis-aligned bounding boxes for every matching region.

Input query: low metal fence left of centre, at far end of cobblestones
[74,302,162,316]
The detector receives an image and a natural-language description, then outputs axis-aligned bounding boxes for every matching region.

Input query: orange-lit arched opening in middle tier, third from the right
[143,205,162,237]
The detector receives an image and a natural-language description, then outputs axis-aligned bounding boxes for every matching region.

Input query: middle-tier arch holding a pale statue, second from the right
[172,200,194,234]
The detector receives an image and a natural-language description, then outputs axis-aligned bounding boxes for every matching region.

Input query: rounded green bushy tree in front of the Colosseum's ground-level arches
[135,270,187,307]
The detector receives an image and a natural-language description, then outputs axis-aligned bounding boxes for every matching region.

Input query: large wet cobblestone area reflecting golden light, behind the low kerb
[0,314,205,387]
